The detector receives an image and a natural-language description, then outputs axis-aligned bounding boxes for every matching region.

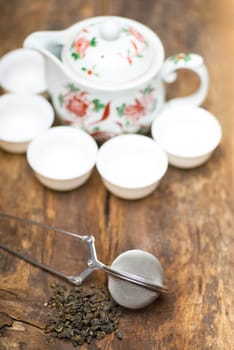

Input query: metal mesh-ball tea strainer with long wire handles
[0,213,168,309]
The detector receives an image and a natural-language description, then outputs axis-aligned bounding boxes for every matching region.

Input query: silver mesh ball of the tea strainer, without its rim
[108,249,163,309]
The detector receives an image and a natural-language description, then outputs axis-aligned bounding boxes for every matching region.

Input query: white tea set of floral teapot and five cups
[0,16,222,199]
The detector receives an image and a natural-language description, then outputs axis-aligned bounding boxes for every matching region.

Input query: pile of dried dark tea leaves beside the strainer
[45,285,123,346]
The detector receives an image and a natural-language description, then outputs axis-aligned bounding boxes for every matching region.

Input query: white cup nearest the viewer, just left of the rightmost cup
[96,134,168,199]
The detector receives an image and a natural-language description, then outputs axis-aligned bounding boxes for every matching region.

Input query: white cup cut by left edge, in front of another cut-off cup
[0,93,54,153]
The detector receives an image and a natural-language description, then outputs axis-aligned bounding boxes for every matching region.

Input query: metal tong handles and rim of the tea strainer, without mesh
[0,213,168,293]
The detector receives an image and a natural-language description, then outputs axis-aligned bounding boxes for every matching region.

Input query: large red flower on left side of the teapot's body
[66,92,89,117]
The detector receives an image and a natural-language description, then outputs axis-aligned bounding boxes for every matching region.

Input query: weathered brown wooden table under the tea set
[0,0,234,350]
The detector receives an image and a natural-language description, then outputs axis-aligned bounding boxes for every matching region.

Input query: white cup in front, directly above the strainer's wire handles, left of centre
[27,126,98,191]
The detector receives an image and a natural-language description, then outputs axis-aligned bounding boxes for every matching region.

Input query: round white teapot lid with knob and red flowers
[62,16,164,89]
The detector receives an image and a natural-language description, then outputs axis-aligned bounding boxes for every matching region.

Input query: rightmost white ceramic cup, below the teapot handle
[151,105,222,168]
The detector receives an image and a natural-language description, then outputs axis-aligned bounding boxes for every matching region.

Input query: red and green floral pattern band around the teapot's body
[58,83,158,142]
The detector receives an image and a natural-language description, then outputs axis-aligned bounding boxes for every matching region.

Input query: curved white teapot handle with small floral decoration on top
[161,53,209,106]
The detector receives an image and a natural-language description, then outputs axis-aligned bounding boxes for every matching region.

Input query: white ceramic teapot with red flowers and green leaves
[24,16,209,142]
